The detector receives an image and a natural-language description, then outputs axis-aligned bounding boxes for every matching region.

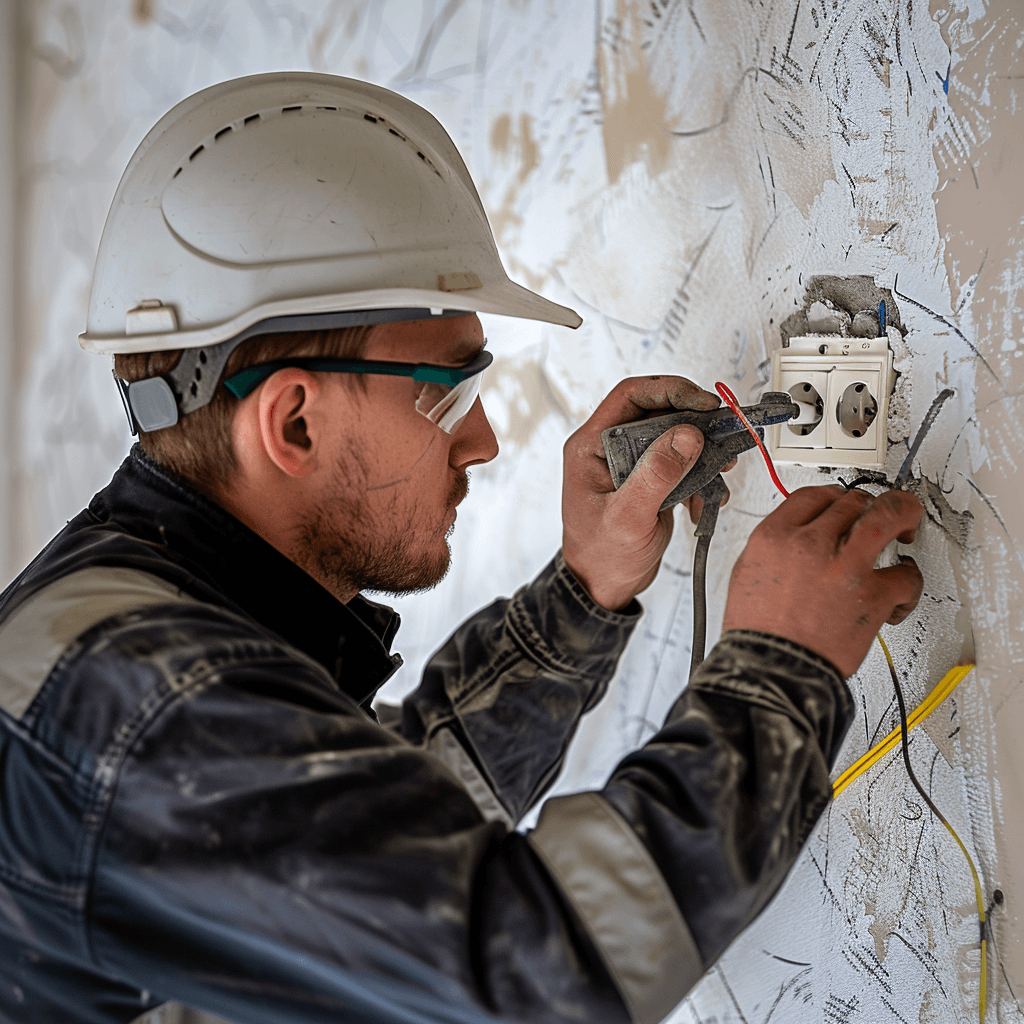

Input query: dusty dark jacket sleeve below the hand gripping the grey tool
[401,553,641,825]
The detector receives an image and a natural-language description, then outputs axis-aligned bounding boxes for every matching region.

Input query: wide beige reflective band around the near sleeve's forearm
[528,793,703,1024]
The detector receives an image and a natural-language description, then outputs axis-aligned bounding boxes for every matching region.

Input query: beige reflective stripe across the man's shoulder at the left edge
[0,565,196,718]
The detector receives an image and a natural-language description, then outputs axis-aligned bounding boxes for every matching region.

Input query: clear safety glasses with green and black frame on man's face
[224,352,494,434]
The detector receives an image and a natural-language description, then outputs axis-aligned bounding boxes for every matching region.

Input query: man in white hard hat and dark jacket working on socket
[0,74,922,1024]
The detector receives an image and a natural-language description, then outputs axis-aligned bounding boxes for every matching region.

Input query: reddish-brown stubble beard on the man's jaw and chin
[295,452,469,596]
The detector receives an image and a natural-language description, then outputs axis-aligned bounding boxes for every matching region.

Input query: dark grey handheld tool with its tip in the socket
[601,391,800,510]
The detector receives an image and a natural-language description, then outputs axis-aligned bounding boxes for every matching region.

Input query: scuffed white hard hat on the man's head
[79,72,582,429]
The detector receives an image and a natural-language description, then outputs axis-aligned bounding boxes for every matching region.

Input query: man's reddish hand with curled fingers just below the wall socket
[723,486,924,678]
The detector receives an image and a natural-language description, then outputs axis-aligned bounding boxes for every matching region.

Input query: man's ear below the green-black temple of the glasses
[253,367,329,476]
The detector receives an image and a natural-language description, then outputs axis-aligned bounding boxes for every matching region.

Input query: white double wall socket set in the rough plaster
[767,327,899,469]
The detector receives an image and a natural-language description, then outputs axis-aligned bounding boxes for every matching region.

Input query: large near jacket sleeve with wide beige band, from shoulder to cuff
[77,598,852,1024]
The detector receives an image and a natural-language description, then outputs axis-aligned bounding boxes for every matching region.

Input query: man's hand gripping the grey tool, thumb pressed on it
[562,377,729,610]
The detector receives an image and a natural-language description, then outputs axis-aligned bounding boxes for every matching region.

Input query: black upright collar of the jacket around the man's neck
[89,444,402,708]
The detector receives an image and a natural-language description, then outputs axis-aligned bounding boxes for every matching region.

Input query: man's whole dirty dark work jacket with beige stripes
[0,450,852,1024]
